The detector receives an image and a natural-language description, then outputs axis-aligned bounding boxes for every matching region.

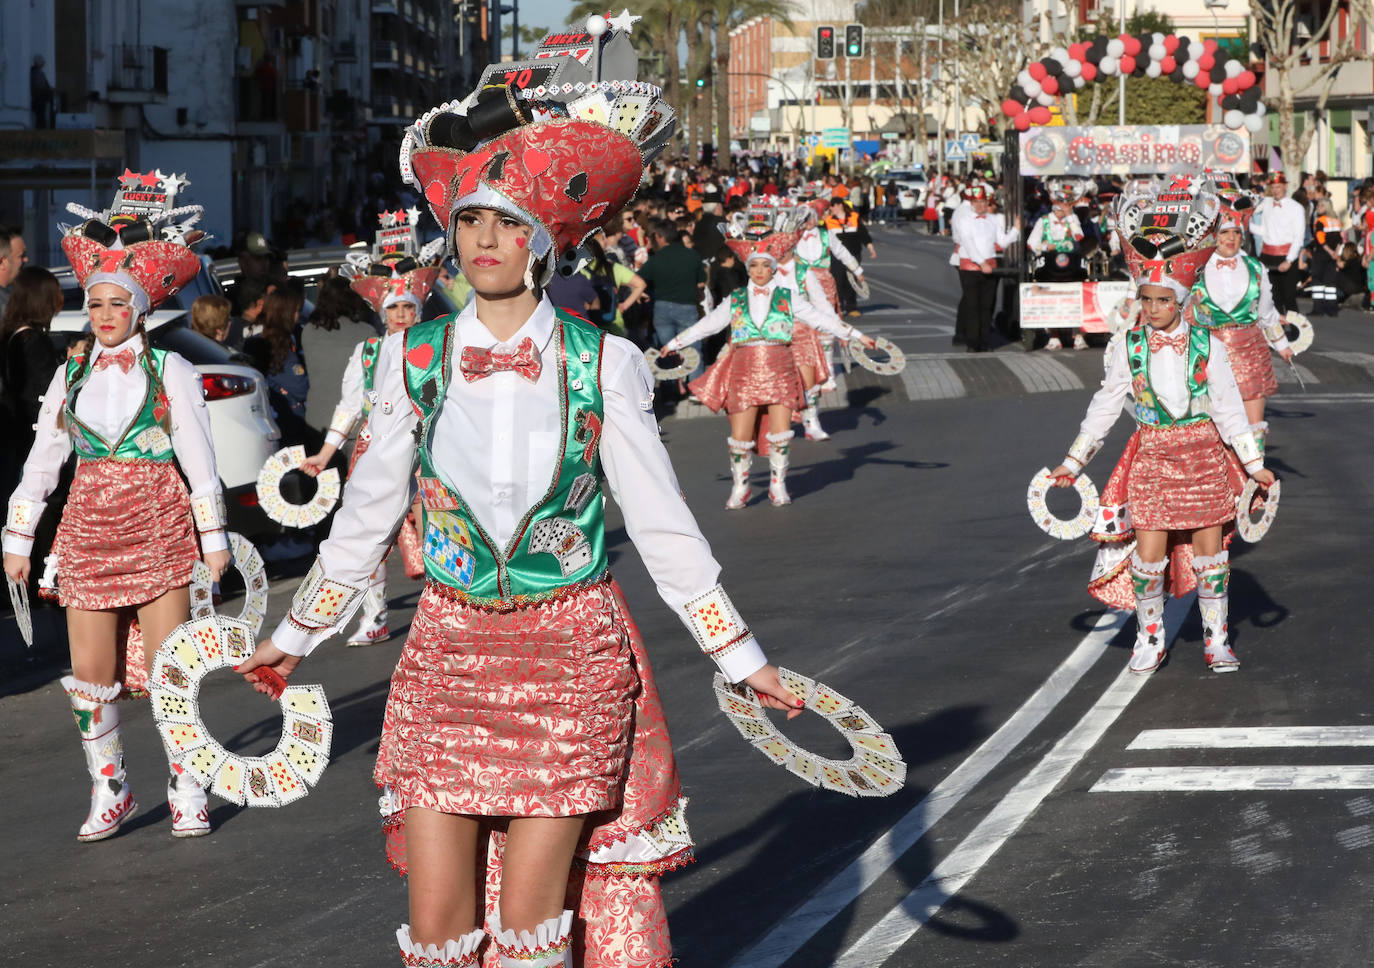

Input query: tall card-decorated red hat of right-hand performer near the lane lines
[1116,173,1223,302]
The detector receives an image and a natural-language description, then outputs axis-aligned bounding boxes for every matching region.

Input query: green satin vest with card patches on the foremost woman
[405,310,607,610]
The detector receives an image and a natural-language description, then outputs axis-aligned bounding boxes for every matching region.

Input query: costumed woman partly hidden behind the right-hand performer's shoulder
[1184,192,1293,453]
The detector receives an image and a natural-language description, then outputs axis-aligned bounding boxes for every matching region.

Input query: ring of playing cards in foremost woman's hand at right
[713,669,907,796]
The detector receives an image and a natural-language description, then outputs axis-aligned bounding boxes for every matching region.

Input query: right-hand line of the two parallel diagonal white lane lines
[834,595,1195,968]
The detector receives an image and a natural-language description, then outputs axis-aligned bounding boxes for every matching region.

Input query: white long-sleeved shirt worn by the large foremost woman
[272,297,765,682]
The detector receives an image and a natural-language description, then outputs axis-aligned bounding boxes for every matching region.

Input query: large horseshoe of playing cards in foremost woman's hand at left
[148,616,334,806]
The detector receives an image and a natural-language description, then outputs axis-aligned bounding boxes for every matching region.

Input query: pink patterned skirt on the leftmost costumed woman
[52,459,199,611]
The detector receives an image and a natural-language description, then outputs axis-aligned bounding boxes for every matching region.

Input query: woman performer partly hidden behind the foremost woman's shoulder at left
[301,215,445,645]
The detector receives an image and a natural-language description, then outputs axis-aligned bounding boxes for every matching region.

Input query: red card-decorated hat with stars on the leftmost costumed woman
[60,169,207,316]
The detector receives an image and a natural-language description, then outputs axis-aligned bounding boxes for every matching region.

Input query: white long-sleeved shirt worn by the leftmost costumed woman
[4,335,229,556]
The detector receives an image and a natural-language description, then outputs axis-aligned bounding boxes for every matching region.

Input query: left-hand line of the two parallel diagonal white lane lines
[731,611,1132,968]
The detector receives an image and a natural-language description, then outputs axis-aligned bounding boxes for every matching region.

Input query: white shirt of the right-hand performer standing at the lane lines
[1079,320,1250,445]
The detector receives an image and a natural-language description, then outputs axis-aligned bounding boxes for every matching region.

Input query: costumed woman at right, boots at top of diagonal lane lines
[1051,185,1274,673]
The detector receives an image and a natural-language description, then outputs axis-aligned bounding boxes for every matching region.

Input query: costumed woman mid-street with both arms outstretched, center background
[664,213,874,511]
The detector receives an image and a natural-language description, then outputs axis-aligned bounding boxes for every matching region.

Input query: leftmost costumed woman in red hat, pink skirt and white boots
[4,172,229,840]
